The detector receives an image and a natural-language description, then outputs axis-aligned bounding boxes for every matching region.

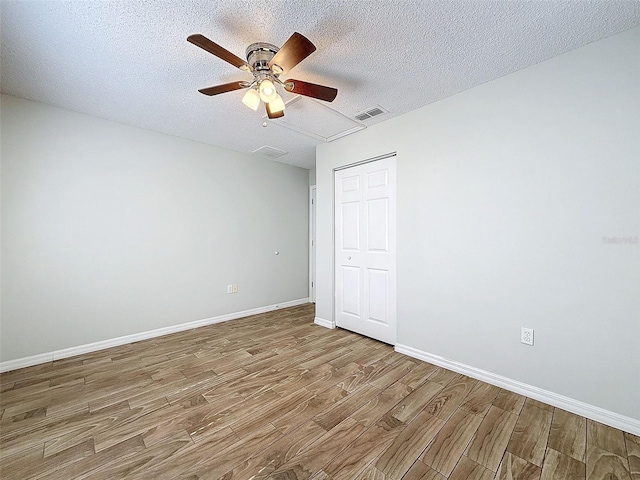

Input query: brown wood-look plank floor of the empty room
[0,305,640,480]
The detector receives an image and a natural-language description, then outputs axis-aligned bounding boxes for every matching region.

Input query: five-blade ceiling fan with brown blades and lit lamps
[187,32,338,118]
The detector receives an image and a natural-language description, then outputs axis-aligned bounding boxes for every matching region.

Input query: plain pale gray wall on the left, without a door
[0,95,309,361]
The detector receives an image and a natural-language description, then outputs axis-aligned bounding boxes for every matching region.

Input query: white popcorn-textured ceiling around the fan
[0,0,640,168]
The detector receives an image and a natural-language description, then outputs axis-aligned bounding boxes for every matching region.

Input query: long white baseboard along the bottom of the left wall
[0,298,309,372]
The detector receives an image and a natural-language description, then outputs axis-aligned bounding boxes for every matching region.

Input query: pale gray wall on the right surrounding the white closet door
[316,28,640,419]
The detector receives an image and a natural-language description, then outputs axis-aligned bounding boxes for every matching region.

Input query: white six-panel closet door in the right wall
[334,157,396,344]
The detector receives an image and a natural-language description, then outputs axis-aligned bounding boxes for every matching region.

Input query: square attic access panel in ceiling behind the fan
[264,96,367,142]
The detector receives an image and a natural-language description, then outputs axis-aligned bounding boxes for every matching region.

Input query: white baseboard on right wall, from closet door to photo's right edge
[396,344,640,435]
